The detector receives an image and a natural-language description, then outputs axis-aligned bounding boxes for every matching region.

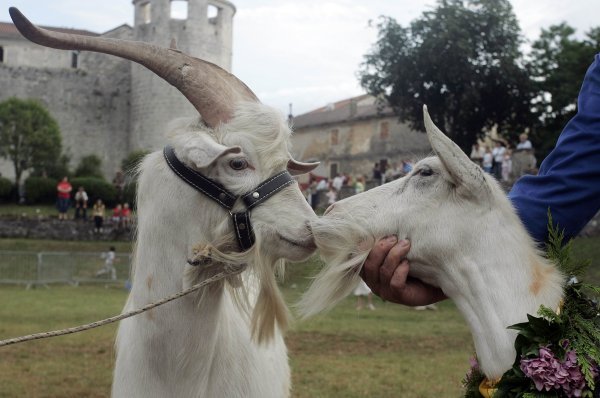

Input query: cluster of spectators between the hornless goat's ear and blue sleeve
[471,133,533,182]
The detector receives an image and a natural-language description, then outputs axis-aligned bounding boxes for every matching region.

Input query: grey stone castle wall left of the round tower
[0,54,130,178]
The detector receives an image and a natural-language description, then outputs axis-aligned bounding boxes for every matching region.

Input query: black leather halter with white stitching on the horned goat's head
[163,146,294,251]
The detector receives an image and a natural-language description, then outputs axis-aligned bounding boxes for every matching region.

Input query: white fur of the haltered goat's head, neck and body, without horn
[112,103,316,398]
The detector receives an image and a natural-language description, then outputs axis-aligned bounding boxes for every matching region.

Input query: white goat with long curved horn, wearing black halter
[10,8,324,398]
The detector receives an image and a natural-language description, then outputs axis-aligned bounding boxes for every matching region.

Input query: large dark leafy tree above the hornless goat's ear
[359,0,531,150]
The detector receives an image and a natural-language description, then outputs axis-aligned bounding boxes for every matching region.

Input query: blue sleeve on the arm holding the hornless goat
[509,54,600,242]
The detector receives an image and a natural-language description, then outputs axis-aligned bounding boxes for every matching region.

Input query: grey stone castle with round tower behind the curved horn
[0,0,235,178]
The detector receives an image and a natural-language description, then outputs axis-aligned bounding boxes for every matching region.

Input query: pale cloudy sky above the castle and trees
[0,0,600,115]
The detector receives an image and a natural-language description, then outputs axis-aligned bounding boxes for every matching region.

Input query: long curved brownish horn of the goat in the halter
[9,7,258,127]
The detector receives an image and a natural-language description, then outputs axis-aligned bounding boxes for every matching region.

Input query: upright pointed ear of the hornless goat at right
[423,105,487,193]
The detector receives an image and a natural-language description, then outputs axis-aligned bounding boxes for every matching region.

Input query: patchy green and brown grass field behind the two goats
[0,238,600,398]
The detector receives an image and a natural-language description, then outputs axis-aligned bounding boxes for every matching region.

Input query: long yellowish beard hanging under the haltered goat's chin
[184,234,291,344]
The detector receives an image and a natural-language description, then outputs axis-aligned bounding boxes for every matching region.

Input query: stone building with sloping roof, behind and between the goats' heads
[292,95,431,183]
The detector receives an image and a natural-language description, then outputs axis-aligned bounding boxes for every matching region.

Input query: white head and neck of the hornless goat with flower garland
[300,108,564,378]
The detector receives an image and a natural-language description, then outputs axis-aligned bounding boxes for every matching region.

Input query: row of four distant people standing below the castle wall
[56,177,132,233]
